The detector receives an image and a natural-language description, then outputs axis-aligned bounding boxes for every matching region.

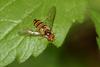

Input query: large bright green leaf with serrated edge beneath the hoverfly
[0,0,87,66]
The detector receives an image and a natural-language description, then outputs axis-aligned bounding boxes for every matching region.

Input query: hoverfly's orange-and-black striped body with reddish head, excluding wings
[33,19,55,41]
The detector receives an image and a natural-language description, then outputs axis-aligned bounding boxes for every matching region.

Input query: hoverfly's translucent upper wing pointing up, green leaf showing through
[44,6,56,30]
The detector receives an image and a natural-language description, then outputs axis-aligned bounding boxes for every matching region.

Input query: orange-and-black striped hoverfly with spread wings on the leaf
[27,6,56,41]
